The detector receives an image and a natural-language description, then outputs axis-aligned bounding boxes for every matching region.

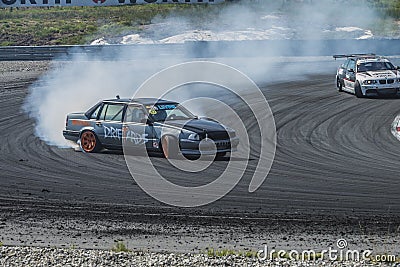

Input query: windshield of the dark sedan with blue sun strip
[146,104,196,122]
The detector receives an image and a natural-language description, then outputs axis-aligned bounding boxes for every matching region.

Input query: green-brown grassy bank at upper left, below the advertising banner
[0,4,219,46]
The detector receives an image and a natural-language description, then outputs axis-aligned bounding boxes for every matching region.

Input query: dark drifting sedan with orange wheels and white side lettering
[63,97,239,158]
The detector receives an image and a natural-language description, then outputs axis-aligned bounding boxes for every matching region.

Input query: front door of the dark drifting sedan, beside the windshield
[123,104,158,151]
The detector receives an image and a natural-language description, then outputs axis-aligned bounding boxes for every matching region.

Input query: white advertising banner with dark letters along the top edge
[0,0,225,7]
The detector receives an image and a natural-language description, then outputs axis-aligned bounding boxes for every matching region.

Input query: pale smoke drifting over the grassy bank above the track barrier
[93,0,400,44]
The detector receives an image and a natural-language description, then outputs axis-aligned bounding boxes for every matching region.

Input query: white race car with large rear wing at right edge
[333,54,400,97]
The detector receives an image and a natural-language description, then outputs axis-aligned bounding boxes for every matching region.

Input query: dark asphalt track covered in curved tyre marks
[0,60,400,251]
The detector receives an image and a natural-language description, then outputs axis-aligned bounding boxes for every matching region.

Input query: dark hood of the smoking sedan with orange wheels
[163,119,226,133]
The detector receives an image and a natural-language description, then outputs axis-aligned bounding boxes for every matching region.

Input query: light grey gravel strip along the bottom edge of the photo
[0,247,400,267]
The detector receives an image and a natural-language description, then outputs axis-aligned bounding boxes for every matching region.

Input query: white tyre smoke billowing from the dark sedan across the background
[24,0,396,147]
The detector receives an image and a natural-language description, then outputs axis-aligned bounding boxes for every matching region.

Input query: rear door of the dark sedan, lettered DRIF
[95,103,126,148]
